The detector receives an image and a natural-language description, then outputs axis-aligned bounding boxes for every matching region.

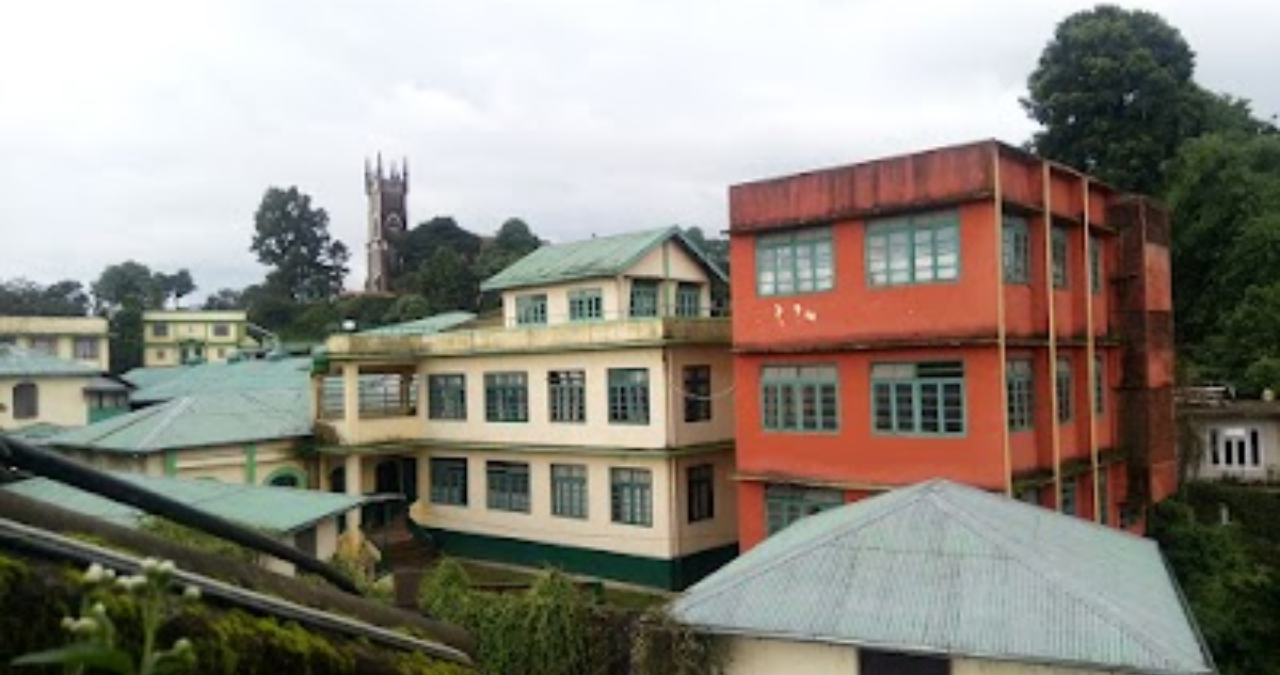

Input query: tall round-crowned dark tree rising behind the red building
[1023,5,1208,195]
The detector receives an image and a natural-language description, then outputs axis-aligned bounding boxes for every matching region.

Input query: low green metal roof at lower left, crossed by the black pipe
[0,473,366,533]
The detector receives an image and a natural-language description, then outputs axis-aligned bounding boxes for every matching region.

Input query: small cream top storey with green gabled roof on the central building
[480,227,727,327]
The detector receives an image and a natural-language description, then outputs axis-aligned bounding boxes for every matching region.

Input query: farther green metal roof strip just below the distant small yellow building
[123,356,311,403]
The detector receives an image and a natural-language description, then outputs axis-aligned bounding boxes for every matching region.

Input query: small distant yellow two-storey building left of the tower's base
[142,310,259,368]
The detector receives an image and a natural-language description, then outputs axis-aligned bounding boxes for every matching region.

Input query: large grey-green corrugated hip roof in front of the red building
[672,480,1213,675]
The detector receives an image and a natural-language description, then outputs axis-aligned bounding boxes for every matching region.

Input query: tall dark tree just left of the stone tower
[250,187,349,302]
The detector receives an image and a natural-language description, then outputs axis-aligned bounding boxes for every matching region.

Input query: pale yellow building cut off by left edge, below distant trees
[0,316,111,373]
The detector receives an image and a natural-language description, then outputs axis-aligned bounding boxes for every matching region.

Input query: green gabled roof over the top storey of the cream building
[480,227,724,291]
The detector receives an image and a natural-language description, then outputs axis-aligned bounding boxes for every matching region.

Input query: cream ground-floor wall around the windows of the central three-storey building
[411,451,737,560]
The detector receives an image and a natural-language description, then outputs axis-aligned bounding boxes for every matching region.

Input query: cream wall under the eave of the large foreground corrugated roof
[726,637,1121,675]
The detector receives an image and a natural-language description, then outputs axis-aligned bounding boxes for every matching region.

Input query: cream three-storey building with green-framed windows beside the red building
[314,228,737,588]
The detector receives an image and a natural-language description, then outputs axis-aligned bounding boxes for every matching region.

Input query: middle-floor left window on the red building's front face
[760,365,840,432]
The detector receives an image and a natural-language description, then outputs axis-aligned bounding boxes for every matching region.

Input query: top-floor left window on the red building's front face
[755,228,836,296]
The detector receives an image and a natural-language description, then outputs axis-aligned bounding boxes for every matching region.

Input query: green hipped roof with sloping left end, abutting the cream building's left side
[49,389,311,453]
